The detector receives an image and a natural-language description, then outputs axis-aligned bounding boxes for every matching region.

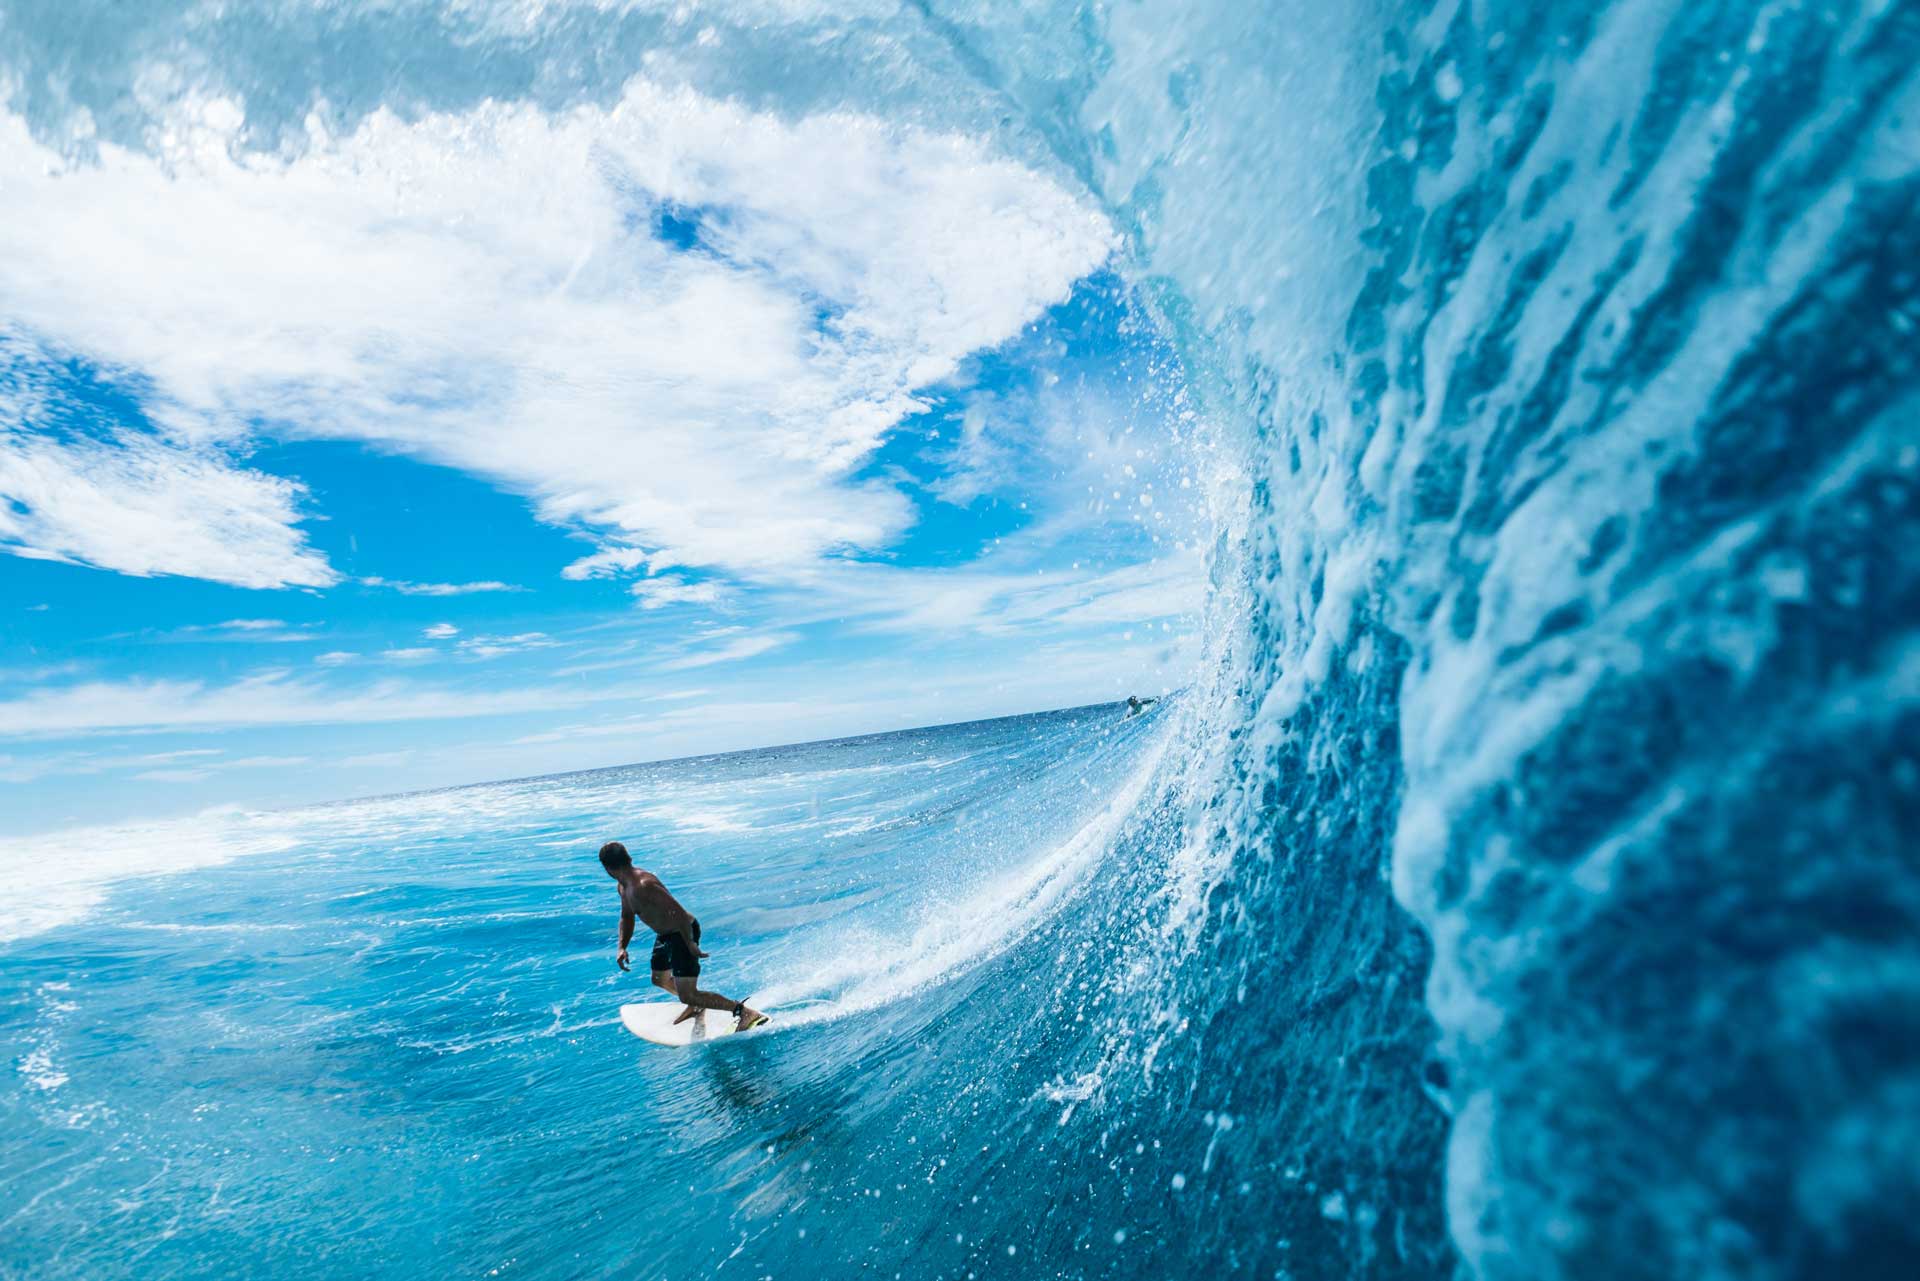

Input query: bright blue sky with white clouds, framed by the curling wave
[0,81,1206,832]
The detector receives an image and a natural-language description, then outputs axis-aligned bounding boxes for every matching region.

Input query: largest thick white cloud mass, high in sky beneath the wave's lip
[0,81,1112,599]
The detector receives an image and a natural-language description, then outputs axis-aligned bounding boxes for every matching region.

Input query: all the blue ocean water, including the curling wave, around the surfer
[0,0,1920,1281]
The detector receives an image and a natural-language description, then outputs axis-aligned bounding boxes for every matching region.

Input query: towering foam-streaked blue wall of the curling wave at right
[1056,2,1920,1277]
